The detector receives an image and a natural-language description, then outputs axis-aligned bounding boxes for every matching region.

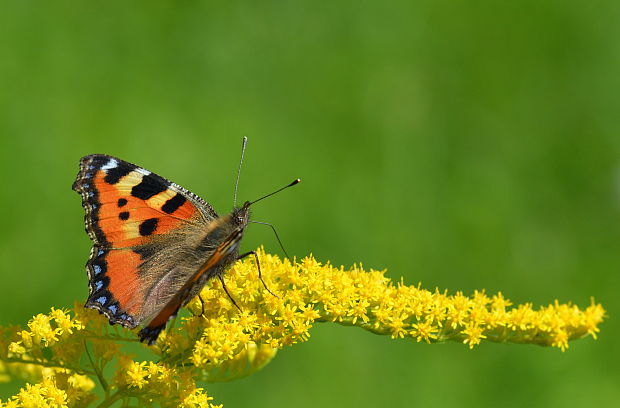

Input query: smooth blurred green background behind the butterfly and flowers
[0,0,620,407]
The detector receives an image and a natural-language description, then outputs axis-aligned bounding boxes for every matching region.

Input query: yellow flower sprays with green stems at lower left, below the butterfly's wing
[0,305,223,408]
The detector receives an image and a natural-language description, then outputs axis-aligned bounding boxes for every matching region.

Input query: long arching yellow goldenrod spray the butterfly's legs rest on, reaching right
[158,251,605,356]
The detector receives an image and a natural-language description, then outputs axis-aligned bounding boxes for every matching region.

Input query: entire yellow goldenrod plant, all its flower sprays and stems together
[0,250,605,408]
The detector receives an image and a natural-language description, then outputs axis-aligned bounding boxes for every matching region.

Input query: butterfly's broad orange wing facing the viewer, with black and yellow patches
[73,154,217,328]
